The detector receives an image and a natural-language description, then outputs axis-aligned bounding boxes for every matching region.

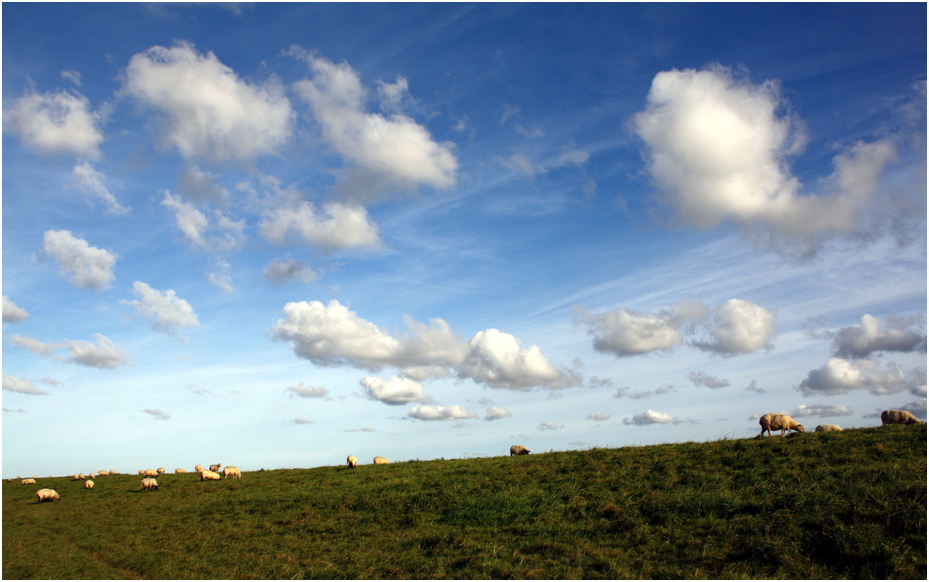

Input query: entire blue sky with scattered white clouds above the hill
[2,3,926,476]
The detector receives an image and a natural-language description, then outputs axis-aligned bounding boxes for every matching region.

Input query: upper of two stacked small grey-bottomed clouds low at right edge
[834,313,926,359]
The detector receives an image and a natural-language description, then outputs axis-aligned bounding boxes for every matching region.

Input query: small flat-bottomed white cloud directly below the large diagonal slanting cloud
[260,201,381,250]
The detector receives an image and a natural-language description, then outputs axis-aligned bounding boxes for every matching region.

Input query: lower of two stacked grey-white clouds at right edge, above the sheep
[799,358,926,396]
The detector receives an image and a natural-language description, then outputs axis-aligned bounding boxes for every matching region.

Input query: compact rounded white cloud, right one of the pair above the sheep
[693,299,777,355]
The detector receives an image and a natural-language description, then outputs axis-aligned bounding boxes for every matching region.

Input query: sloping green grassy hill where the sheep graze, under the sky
[3,424,926,580]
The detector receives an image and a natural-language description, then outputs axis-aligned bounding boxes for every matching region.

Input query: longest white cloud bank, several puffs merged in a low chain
[272,300,580,390]
